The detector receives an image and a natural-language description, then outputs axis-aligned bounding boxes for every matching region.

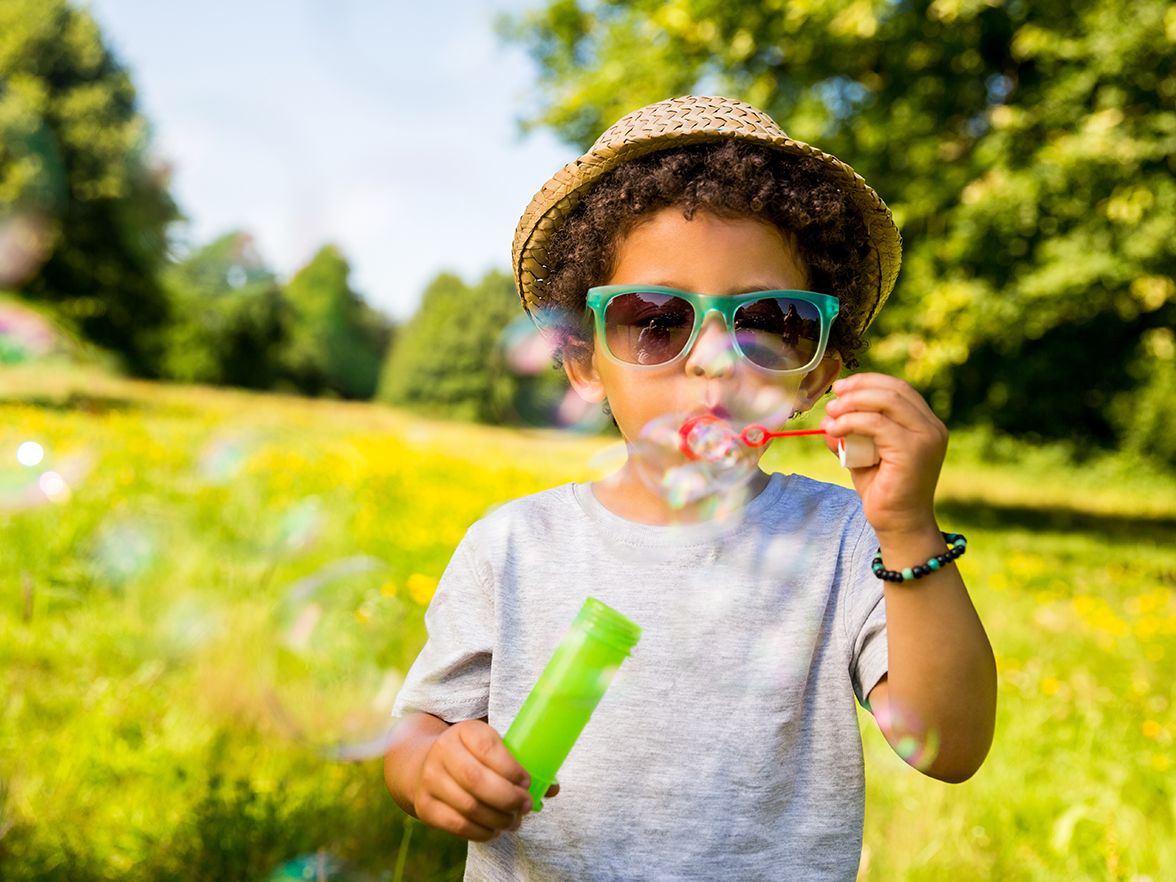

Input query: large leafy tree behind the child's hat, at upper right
[502,0,1176,456]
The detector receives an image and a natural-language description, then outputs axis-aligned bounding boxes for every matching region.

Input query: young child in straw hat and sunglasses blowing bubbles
[386,96,996,880]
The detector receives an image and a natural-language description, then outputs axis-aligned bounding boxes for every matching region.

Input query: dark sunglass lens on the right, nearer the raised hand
[735,298,821,370]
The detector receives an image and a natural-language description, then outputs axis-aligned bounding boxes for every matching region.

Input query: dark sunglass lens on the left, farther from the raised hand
[604,292,694,365]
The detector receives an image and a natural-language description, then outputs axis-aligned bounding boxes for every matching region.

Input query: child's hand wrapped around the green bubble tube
[413,720,543,842]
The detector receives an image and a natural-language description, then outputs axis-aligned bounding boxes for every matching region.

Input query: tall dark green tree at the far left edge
[0,0,178,375]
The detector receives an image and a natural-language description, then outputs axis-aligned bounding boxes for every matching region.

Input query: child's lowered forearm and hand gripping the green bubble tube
[383,714,536,842]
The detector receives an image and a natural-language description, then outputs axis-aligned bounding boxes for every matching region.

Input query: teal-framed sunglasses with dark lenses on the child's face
[588,285,838,374]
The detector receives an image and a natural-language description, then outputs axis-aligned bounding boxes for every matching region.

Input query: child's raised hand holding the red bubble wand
[821,374,948,540]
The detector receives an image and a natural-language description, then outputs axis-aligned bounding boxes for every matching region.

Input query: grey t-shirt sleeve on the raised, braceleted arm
[842,512,889,707]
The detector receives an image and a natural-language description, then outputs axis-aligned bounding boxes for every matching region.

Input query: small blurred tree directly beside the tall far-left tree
[163,233,292,389]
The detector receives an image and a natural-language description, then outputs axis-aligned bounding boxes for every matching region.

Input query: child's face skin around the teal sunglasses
[566,207,841,440]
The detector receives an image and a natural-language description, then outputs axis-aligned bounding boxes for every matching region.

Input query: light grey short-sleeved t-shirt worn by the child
[393,474,887,882]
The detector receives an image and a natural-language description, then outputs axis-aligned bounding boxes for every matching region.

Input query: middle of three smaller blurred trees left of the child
[285,245,392,399]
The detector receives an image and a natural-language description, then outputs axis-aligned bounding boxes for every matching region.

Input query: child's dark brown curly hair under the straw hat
[542,140,871,367]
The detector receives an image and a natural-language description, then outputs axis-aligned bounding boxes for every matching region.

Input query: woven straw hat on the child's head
[512,95,902,330]
